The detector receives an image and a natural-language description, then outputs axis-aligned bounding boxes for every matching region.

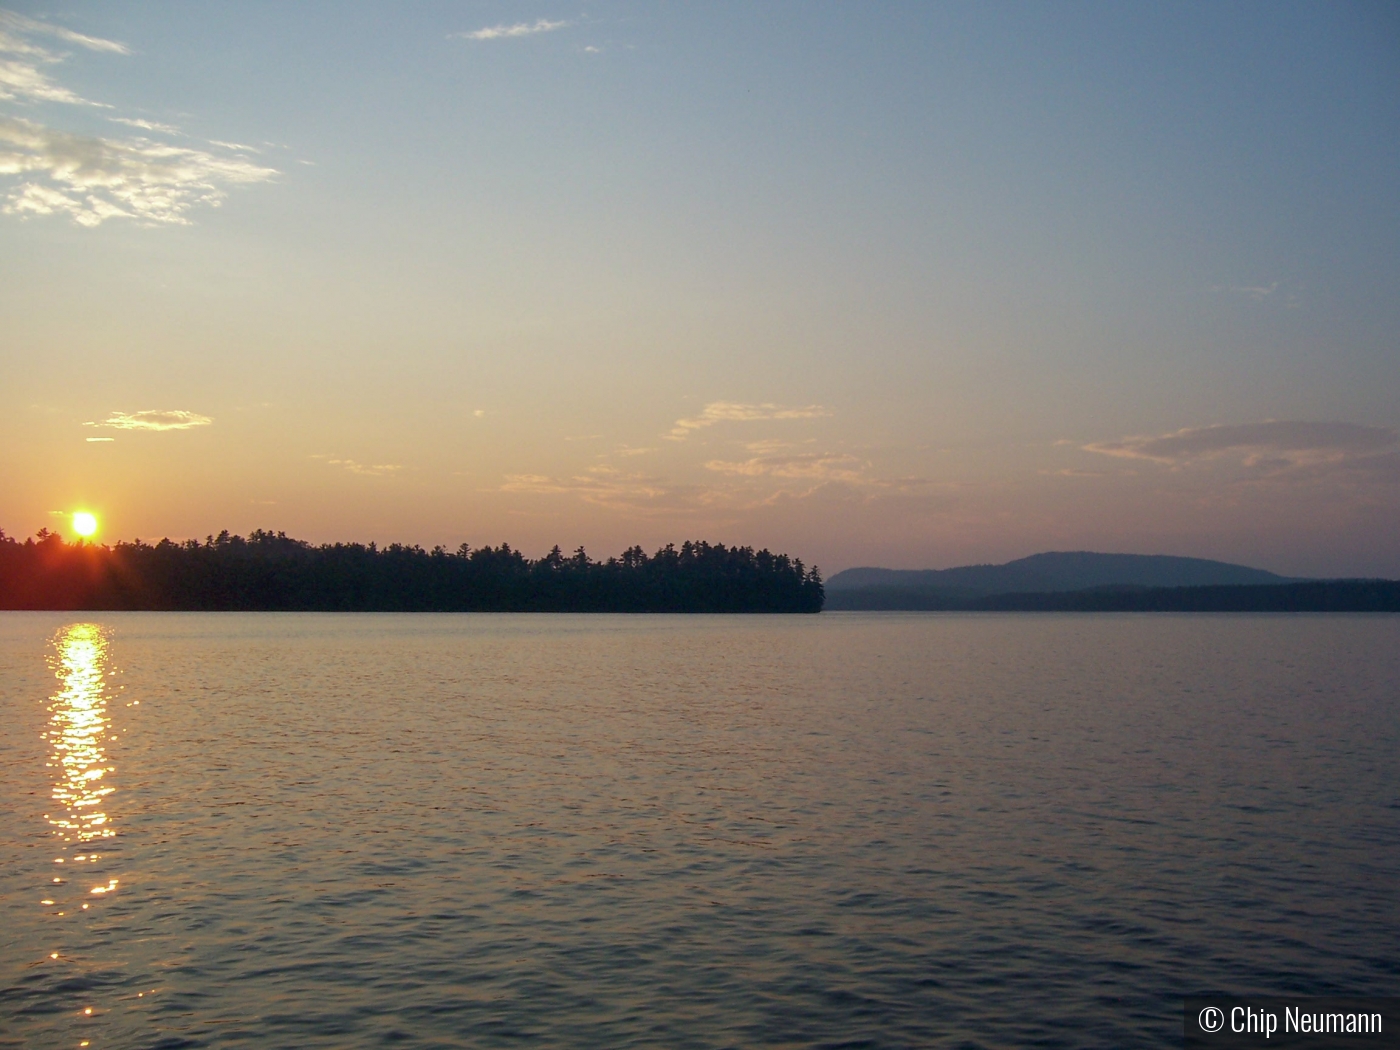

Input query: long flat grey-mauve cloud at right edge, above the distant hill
[1084,420,1400,468]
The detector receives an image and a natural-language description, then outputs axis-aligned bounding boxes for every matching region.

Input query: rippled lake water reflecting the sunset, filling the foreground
[0,613,1400,1049]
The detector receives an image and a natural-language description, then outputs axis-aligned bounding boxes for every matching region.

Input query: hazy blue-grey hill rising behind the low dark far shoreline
[826,550,1301,609]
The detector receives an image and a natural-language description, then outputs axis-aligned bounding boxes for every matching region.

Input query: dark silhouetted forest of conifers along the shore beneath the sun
[0,531,825,613]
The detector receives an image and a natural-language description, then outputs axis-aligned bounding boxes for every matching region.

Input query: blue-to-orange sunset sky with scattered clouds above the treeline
[0,0,1400,577]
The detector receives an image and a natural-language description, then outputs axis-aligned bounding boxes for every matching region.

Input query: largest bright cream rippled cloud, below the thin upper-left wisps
[0,116,277,227]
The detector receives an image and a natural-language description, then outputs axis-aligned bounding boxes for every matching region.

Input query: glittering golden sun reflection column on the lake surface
[45,623,116,845]
